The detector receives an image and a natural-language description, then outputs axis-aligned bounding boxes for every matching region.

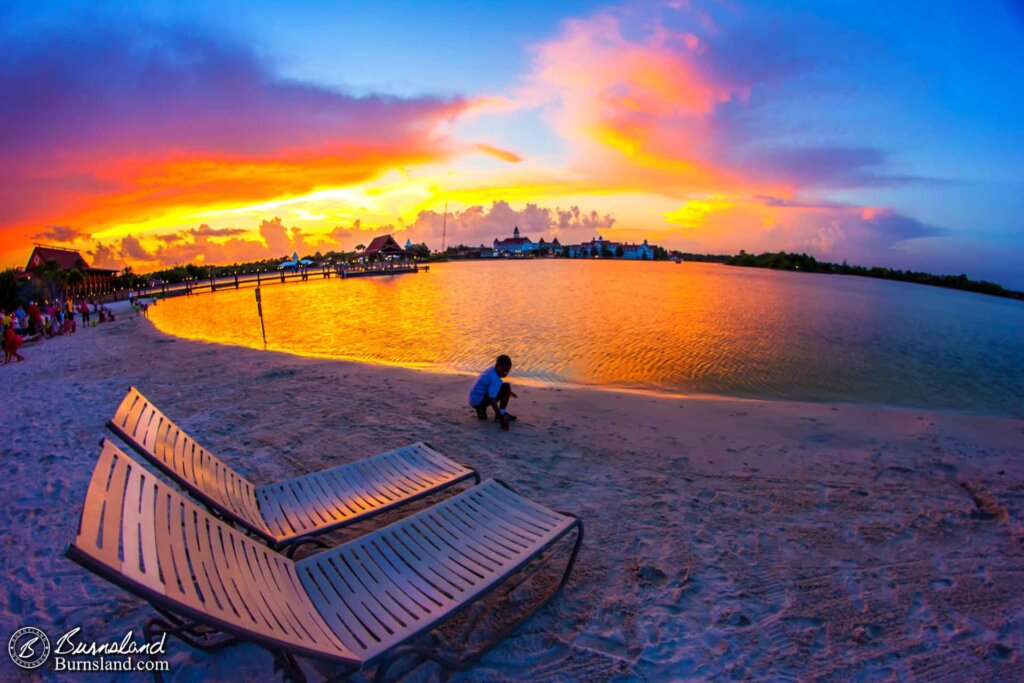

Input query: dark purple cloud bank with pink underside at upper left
[0,26,460,164]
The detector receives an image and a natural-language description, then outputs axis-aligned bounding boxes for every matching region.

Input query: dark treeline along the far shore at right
[723,250,1024,301]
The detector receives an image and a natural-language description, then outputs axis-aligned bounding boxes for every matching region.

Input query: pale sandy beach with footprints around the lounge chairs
[0,315,1024,681]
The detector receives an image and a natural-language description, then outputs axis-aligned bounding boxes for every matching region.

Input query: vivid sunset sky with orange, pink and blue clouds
[0,0,1024,289]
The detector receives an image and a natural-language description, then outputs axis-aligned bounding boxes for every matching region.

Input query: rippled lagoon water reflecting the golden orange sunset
[151,260,1024,417]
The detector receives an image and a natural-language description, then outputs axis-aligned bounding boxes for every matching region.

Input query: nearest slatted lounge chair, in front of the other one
[67,439,583,680]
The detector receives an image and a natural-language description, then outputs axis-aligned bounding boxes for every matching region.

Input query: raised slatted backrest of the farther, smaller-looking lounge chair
[108,387,272,540]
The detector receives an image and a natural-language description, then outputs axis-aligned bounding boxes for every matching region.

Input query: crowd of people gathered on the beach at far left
[0,297,134,365]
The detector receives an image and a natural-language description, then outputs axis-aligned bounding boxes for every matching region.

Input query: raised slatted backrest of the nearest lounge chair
[68,439,357,664]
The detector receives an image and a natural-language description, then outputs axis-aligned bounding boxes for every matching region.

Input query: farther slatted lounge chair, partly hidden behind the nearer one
[108,387,480,552]
